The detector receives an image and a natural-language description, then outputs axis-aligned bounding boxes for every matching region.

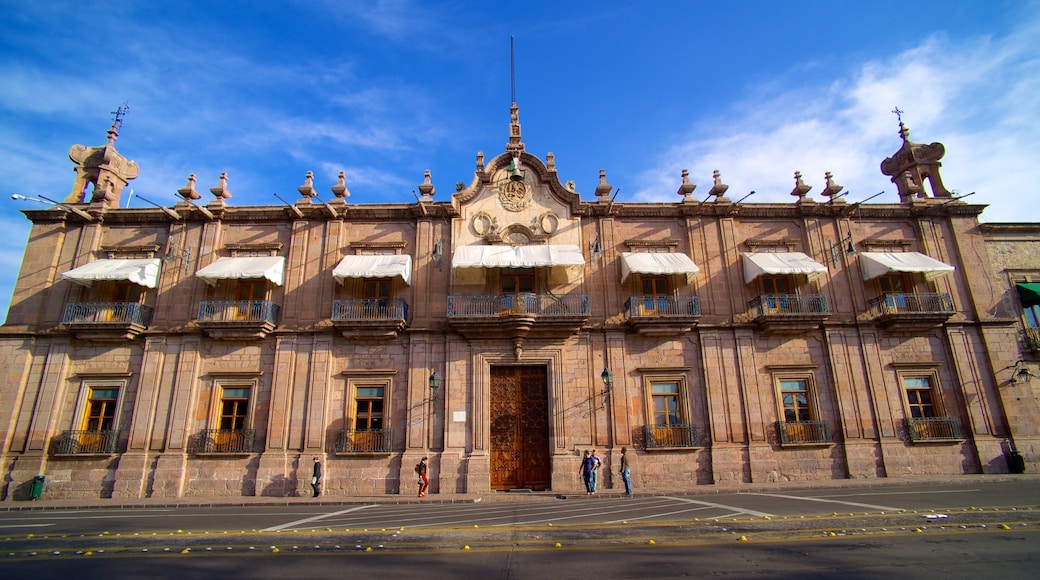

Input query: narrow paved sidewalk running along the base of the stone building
[0,474,1040,511]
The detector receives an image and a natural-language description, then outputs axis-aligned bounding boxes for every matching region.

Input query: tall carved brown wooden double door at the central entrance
[491,366,552,491]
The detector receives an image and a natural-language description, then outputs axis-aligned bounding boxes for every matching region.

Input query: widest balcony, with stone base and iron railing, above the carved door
[447,293,589,342]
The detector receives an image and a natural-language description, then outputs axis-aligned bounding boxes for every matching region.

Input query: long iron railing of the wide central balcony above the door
[448,293,589,318]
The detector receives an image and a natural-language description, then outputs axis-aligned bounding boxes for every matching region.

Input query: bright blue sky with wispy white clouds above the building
[0,0,1040,320]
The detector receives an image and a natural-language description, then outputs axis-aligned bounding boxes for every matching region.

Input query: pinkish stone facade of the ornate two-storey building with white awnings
[0,111,1040,501]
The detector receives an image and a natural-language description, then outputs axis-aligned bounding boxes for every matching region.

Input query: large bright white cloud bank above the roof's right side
[635,21,1040,221]
